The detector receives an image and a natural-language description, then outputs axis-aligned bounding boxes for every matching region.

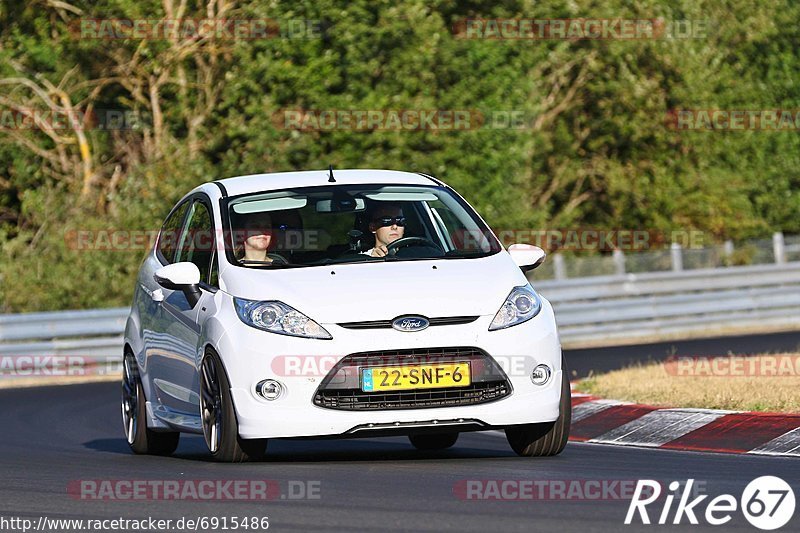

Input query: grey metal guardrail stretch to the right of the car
[532,262,800,347]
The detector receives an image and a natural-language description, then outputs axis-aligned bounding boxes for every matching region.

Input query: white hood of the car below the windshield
[221,251,527,324]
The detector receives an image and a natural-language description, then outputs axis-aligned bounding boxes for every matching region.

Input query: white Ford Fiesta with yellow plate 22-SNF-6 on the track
[122,170,571,461]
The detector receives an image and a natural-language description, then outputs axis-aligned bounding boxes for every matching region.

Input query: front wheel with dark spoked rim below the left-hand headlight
[200,350,267,463]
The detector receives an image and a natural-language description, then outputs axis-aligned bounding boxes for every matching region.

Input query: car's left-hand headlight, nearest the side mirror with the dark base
[233,297,333,339]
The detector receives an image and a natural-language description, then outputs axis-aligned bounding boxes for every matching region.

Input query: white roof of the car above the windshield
[216,169,439,196]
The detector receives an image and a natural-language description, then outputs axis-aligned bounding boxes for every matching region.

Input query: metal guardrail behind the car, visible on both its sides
[0,262,800,375]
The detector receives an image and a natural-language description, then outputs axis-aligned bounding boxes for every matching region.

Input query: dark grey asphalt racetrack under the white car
[0,383,800,532]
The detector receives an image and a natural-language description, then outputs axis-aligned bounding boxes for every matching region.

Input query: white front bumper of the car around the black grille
[215,300,562,439]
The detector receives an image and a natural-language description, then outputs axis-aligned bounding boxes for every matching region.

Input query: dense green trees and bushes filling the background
[0,0,800,311]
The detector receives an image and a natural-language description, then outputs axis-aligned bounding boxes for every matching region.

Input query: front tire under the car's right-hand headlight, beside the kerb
[506,356,572,457]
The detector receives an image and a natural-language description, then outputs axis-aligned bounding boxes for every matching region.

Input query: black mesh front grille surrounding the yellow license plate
[314,347,511,411]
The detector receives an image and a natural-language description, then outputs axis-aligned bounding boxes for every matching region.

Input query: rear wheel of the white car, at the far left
[122,351,181,455]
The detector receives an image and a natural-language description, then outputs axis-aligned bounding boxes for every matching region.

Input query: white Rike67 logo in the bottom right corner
[625,476,795,531]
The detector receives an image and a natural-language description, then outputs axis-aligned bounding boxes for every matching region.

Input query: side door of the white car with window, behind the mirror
[149,196,216,416]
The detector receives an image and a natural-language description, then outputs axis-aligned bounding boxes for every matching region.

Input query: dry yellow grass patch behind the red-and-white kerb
[576,354,800,413]
